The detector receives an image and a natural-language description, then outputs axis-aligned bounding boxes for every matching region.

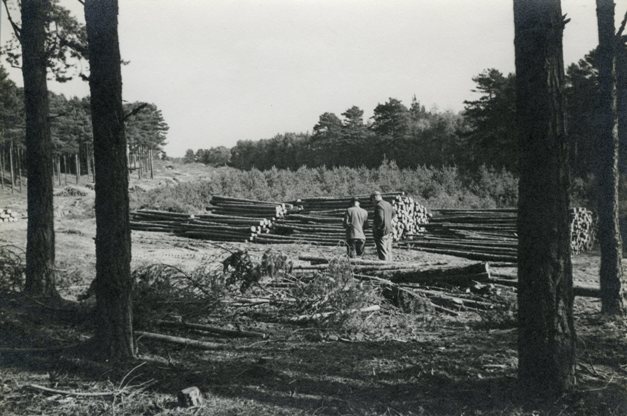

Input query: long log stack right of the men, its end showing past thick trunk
[399,208,596,263]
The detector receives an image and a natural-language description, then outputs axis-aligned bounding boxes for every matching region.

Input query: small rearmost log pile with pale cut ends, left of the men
[207,195,299,220]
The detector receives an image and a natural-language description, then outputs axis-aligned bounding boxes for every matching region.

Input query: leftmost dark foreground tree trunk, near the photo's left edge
[21,0,56,296]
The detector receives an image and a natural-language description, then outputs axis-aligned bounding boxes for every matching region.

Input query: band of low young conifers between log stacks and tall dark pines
[131,162,518,212]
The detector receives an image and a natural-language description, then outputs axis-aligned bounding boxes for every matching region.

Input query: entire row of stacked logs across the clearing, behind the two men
[127,193,596,255]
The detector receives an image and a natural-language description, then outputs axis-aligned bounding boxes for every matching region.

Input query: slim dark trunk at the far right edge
[596,0,623,315]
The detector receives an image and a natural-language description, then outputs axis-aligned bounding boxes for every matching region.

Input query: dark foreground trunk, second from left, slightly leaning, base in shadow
[85,0,134,360]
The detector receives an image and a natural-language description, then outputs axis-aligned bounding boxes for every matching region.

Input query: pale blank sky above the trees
[1,0,627,156]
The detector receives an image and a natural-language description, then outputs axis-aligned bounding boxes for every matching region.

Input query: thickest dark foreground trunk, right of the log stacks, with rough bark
[514,0,575,395]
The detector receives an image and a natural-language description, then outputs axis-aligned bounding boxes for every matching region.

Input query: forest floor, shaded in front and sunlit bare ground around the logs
[0,165,627,416]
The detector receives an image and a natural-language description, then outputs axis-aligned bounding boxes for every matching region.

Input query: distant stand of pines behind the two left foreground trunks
[0,66,169,187]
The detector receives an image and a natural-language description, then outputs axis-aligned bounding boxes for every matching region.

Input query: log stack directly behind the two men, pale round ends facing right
[255,192,430,245]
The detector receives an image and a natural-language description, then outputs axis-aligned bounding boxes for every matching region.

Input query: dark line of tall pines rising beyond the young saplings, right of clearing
[184,49,627,178]
